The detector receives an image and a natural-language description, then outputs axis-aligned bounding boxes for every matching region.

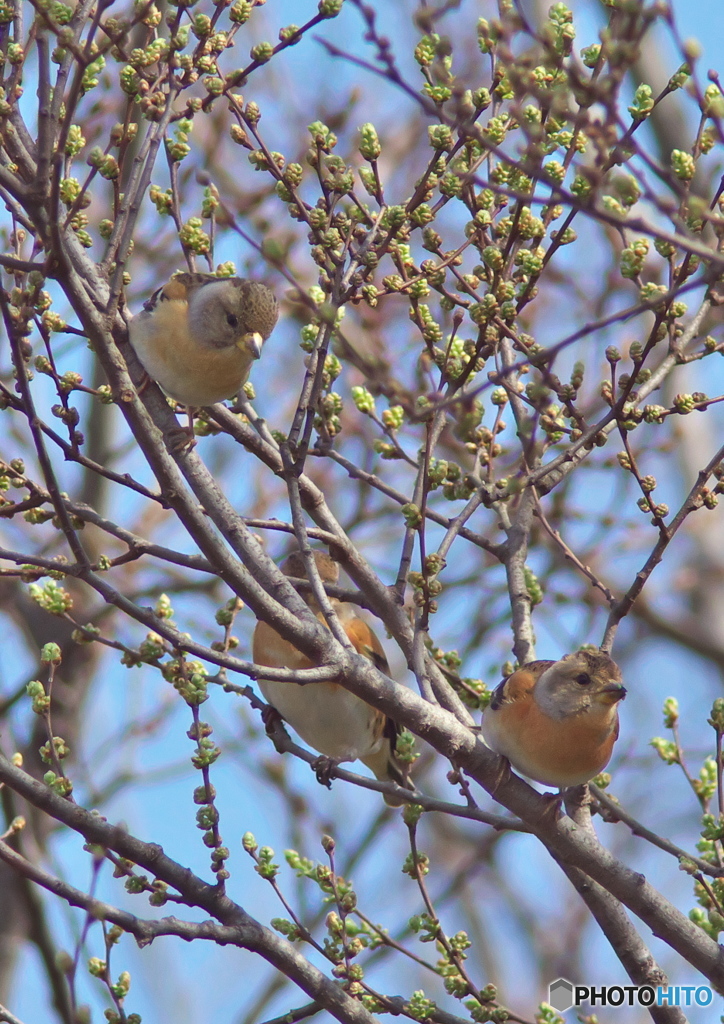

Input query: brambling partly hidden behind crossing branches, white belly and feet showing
[253,551,413,807]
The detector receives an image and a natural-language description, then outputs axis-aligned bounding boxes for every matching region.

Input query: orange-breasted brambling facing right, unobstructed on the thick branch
[481,650,626,788]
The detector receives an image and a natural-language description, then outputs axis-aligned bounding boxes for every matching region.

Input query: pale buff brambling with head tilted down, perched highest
[129,273,279,408]
